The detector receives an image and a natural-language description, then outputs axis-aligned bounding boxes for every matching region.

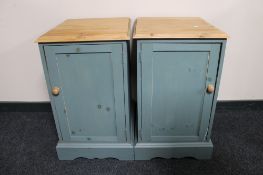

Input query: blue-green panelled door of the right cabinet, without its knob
[138,42,220,142]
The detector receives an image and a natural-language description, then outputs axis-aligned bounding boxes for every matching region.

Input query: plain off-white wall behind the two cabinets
[0,0,263,102]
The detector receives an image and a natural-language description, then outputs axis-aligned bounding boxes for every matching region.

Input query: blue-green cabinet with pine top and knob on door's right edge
[133,18,227,160]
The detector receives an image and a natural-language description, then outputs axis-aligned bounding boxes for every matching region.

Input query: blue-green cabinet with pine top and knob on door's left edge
[37,18,134,160]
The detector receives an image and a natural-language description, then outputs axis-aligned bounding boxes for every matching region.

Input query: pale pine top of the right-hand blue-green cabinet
[133,17,228,39]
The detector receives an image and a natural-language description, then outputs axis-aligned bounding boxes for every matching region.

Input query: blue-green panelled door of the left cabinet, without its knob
[44,44,126,142]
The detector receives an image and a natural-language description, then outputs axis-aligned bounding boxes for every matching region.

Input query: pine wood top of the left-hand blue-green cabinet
[36,18,130,43]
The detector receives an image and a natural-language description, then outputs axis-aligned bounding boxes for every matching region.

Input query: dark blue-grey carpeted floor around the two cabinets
[0,105,263,175]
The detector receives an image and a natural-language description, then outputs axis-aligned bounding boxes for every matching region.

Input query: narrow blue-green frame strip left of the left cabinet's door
[39,44,63,140]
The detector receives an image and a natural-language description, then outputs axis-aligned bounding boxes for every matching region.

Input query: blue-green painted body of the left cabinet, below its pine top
[40,42,134,160]
